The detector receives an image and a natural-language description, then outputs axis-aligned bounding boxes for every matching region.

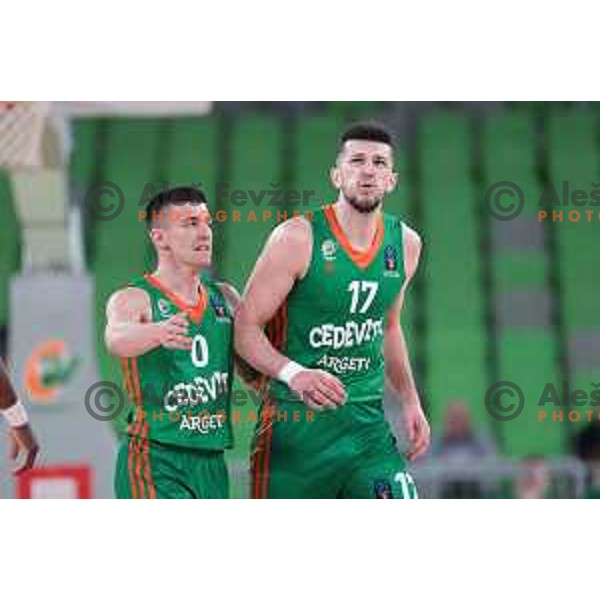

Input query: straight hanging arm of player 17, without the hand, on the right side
[384,227,422,404]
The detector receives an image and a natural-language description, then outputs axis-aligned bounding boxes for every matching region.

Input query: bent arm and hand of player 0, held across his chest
[104,288,191,358]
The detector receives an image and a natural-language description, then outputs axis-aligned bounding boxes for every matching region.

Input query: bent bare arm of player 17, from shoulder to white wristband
[235,220,312,377]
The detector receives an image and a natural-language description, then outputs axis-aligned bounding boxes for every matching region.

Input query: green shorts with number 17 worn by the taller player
[250,401,418,499]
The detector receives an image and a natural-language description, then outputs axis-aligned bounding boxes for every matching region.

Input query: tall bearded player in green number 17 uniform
[235,124,430,499]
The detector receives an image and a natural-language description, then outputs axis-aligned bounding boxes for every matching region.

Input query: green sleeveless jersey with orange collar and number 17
[267,205,405,402]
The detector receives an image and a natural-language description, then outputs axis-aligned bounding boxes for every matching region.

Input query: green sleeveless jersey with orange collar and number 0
[122,274,233,450]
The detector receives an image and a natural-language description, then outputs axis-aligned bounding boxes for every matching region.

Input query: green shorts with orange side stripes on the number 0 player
[115,437,229,499]
